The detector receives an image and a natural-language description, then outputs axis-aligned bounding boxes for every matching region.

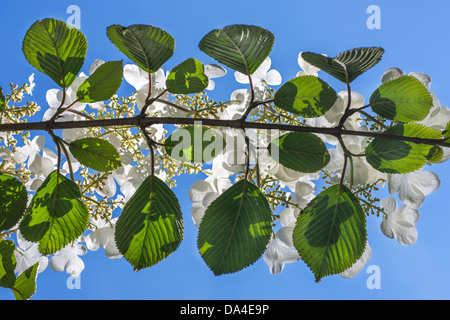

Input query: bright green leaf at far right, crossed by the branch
[365,123,442,174]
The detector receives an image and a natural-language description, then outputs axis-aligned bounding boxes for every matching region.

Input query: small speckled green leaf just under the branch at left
[69,138,122,172]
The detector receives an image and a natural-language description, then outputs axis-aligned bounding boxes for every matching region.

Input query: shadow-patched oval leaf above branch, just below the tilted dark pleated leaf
[274,76,337,118]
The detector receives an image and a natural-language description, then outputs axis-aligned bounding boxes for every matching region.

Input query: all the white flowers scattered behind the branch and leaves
[0,53,450,277]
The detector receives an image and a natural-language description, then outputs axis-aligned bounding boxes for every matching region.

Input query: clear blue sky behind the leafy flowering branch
[0,0,450,300]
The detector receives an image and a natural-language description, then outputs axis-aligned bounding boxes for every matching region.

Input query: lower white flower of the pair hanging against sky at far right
[381,197,420,246]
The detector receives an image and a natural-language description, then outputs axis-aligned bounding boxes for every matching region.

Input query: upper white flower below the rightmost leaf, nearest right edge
[388,171,441,209]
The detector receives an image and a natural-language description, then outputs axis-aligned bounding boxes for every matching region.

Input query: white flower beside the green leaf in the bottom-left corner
[14,232,48,275]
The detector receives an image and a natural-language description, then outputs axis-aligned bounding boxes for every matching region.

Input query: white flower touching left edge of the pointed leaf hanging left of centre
[86,218,122,259]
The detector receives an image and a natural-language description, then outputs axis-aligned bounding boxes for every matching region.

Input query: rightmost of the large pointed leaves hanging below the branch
[293,185,367,282]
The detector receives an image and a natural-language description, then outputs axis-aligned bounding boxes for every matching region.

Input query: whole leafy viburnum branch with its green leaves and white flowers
[0,19,450,299]
